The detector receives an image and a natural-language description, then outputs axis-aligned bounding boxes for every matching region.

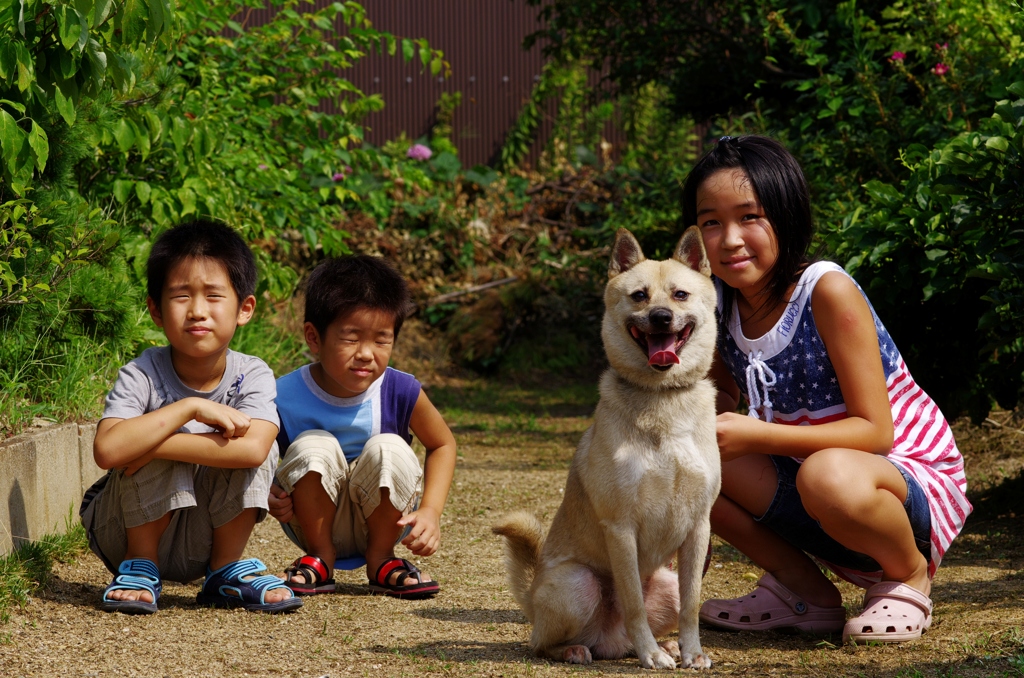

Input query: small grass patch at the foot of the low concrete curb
[0,514,89,624]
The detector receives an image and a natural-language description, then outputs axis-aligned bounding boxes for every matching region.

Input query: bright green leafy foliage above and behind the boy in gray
[0,0,449,428]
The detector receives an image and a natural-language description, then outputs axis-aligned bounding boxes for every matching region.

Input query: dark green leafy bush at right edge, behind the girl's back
[829,81,1024,420]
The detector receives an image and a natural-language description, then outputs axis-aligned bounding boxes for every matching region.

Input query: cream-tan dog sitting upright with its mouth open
[493,226,721,669]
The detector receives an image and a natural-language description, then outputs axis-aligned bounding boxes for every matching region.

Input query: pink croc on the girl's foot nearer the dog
[700,574,846,634]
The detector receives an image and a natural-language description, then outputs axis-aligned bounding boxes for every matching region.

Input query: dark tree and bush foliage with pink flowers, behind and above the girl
[530,0,1024,418]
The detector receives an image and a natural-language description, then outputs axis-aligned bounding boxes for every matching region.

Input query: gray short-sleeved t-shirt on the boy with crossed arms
[103,346,281,438]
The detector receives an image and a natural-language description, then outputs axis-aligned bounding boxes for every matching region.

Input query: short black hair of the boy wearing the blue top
[305,254,412,338]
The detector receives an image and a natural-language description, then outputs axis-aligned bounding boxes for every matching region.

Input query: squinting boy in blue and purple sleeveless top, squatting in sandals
[269,256,456,598]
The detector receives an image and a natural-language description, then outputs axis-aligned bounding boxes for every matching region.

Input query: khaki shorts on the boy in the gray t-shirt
[80,454,278,583]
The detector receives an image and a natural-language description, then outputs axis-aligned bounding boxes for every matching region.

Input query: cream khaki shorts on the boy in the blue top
[278,429,423,558]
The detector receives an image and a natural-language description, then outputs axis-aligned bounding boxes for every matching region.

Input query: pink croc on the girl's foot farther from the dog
[843,582,932,643]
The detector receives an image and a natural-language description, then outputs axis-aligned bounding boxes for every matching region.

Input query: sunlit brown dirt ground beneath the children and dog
[0,368,1024,678]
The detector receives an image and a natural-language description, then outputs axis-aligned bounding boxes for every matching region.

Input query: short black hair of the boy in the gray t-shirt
[145,219,256,304]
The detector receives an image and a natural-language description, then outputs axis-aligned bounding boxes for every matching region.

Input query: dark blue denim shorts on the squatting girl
[756,455,932,573]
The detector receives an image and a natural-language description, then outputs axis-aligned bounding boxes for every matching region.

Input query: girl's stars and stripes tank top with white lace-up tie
[716,261,972,586]
